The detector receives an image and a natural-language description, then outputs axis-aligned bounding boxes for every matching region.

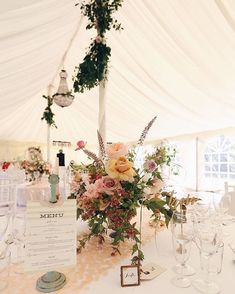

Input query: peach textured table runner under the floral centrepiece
[4,211,162,294]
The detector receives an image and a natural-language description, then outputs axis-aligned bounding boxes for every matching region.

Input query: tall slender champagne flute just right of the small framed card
[171,210,193,288]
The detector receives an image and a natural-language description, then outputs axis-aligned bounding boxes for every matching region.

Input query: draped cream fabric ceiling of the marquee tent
[0,0,235,144]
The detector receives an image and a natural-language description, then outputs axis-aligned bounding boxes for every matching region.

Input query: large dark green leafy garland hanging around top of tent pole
[73,0,123,93]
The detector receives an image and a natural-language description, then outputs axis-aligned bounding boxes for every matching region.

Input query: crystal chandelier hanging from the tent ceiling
[52,69,74,107]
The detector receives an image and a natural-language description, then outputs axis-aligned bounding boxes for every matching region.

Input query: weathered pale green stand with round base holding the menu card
[36,174,66,293]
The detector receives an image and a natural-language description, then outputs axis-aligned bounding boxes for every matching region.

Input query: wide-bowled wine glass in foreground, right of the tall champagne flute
[193,216,221,294]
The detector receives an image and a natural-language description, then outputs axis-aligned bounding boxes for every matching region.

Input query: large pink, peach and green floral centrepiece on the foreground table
[70,118,175,263]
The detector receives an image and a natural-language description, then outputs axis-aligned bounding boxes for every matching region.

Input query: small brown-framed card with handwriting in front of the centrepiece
[121,265,140,287]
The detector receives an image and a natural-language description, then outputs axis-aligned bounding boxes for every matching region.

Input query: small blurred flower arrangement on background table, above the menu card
[20,147,50,182]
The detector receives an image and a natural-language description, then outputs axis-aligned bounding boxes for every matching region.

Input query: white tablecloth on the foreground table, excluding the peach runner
[81,224,235,294]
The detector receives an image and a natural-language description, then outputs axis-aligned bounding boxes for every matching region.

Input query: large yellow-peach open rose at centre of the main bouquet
[105,156,136,182]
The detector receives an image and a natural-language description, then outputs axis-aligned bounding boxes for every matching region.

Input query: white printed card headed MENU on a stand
[25,199,77,271]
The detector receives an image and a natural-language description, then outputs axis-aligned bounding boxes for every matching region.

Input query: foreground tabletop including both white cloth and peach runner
[4,223,235,294]
